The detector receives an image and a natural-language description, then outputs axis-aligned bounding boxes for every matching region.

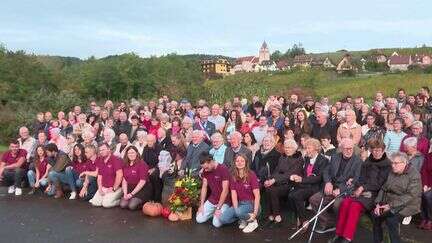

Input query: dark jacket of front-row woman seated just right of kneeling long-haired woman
[251,148,281,182]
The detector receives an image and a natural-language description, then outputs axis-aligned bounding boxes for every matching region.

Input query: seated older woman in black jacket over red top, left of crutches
[288,138,328,230]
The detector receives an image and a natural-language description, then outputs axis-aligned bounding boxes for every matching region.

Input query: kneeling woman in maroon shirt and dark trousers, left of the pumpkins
[120,146,153,210]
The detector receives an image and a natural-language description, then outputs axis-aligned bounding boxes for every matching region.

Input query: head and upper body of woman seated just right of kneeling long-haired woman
[251,135,281,184]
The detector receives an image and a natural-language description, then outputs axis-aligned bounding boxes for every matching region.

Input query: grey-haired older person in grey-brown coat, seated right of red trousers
[373,152,422,243]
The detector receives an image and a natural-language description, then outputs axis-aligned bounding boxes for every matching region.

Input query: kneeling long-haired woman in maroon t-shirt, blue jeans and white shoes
[220,154,260,233]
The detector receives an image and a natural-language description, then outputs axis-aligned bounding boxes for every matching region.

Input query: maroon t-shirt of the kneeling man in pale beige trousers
[96,155,123,187]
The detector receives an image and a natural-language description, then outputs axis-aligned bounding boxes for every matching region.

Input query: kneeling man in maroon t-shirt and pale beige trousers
[89,143,123,208]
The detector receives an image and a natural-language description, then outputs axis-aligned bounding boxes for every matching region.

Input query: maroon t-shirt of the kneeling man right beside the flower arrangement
[202,164,230,205]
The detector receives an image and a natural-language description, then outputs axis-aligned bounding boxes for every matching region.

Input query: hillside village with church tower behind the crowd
[201,41,432,79]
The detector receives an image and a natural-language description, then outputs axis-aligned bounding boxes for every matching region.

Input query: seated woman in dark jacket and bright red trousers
[331,140,391,242]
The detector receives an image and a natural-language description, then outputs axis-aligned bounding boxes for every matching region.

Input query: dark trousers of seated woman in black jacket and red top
[288,188,316,222]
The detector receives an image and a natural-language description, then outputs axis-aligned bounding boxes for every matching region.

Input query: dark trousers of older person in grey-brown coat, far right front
[372,212,402,243]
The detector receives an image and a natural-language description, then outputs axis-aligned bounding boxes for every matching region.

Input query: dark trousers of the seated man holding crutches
[309,192,343,227]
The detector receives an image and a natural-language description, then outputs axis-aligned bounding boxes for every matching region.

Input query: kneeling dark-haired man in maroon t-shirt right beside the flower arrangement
[196,152,230,227]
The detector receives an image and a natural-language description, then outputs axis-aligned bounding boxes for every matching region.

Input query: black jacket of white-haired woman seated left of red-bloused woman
[270,151,303,185]
